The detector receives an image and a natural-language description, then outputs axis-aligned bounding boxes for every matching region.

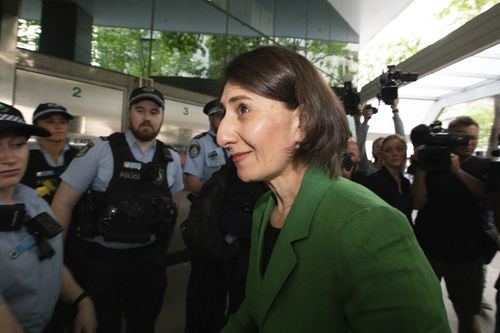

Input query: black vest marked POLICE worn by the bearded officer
[91,133,177,243]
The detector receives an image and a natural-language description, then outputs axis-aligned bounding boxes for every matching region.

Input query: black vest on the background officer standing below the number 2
[21,147,78,203]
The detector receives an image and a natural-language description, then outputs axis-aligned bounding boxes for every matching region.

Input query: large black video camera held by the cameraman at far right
[418,120,470,171]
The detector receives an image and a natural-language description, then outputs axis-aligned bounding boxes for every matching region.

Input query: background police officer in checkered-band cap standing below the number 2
[21,103,78,203]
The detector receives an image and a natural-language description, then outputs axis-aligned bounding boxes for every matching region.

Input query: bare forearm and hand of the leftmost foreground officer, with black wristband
[61,266,97,333]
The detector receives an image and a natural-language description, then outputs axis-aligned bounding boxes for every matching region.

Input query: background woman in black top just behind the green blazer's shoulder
[365,134,413,225]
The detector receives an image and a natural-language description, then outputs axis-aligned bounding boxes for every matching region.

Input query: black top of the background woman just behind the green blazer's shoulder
[365,166,413,225]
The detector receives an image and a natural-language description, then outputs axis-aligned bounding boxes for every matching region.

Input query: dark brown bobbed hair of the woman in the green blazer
[223,46,349,177]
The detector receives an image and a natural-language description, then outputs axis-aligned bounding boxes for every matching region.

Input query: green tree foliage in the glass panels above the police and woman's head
[18,20,358,85]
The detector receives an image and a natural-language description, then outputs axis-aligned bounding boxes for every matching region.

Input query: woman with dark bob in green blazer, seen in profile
[217,46,449,333]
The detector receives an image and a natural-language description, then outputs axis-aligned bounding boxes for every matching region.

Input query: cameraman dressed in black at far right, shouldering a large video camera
[412,116,489,332]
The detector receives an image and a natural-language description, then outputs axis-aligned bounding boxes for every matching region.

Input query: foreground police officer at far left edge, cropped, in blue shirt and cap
[0,103,96,333]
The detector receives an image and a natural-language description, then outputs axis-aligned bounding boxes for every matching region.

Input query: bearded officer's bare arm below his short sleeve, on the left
[52,181,82,235]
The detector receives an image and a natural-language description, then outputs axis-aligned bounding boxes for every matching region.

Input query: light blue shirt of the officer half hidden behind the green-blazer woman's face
[184,129,228,181]
